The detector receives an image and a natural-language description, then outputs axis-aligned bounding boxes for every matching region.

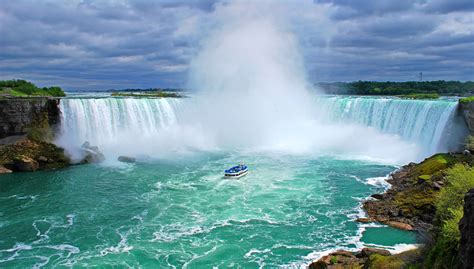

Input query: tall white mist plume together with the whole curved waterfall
[58,9,464,163]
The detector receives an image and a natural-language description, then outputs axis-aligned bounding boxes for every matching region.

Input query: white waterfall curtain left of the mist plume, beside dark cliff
[58,98,181,158]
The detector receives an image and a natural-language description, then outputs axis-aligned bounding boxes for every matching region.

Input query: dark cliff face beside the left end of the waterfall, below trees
[0,98,60,139]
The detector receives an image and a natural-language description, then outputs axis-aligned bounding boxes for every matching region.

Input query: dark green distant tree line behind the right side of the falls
[317,80,474,96]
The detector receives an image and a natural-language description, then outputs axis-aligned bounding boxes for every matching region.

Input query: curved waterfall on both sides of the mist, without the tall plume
[58,96,465,160]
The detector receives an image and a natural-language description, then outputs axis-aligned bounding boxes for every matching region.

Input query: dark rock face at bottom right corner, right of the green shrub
[459,189,474,269]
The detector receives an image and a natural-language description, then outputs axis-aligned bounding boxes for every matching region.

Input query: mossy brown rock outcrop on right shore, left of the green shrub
[358,154,474,231]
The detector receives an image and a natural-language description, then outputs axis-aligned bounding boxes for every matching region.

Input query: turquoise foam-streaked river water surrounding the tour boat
[0,154,420,268]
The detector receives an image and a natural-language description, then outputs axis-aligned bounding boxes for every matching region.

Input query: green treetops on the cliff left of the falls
[0,79,66,97]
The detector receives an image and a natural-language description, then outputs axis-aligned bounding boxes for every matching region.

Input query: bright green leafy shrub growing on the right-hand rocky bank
[425,164,474,268]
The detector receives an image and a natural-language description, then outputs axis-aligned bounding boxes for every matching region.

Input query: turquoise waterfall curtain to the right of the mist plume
[316,96,464,155]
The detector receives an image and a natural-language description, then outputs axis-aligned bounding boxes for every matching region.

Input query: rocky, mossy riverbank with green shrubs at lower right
[309,150,474,269]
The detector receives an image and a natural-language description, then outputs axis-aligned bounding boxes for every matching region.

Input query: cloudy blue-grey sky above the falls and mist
[0,0,474,90]
